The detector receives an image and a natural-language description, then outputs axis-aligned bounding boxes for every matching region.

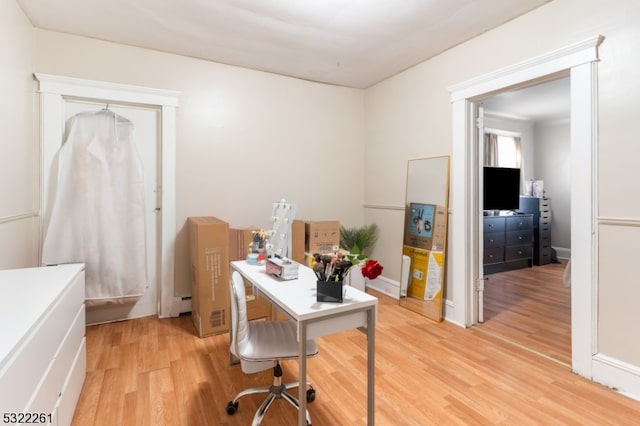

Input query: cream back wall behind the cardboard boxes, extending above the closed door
[35,30,364,295]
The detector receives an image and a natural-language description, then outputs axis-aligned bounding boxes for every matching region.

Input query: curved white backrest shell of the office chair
[229,271,275,373]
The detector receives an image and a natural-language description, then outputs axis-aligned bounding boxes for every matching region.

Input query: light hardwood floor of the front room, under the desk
[73,282,640,426]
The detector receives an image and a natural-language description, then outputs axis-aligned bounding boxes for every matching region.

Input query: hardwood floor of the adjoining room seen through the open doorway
[479,260,571,367]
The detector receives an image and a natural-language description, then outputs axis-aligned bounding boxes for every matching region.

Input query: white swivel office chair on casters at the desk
[227,271,318,426]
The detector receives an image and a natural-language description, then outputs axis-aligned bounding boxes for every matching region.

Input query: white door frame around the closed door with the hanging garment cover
[34,73,179,318]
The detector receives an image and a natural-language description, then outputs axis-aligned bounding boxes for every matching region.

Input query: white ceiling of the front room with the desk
[16,0,551,88]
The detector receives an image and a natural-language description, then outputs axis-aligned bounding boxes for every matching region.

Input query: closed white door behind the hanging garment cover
[64,99,160,324]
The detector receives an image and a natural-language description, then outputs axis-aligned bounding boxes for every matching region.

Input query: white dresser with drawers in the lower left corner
[0,264,86,425]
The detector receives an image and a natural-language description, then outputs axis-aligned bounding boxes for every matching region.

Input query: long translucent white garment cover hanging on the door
[42,109,147,305]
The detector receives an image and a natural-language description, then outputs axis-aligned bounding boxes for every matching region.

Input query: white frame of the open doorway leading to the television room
[447,35,604,378]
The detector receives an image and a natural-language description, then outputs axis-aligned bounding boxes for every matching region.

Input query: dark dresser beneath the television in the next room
[482,214,533,274]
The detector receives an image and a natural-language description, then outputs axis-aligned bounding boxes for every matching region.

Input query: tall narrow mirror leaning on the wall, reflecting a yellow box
[400,156,449,321]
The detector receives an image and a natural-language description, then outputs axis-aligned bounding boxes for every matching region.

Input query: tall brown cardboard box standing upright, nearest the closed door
[188,216,230,337]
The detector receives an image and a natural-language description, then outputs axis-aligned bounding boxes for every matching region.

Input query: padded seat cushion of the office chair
[237,321,318,361]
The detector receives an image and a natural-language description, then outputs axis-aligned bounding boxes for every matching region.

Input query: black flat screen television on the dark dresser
[482,166,520,210]
